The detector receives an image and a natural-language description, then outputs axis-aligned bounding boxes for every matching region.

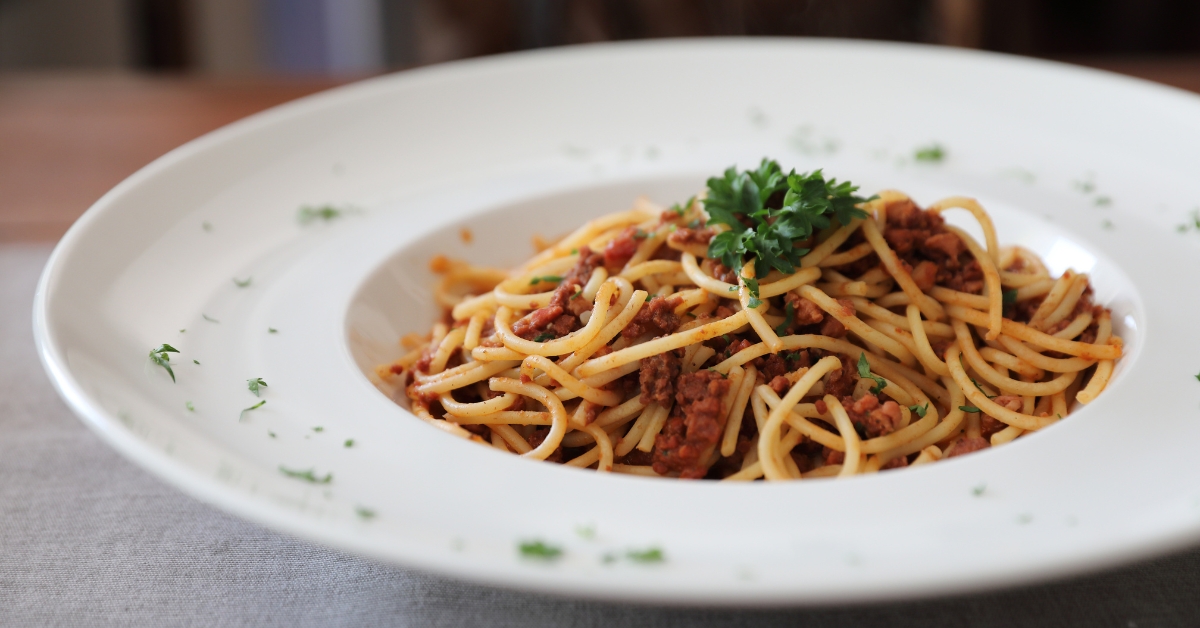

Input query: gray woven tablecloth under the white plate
[0,245,1200,628]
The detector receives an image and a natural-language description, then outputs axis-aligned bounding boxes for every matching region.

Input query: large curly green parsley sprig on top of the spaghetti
[704,159,868,277]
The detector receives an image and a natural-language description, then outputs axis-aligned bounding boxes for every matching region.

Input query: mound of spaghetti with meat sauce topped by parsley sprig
[379,160,1122,482]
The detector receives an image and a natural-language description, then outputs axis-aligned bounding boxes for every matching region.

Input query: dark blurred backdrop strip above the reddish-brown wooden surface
[0,0,1200,76]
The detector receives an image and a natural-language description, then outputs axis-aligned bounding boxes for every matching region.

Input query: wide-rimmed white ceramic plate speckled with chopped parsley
[35,40,1200,604]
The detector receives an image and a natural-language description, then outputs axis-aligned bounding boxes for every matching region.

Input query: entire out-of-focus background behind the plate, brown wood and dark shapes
[0,0,1200,243]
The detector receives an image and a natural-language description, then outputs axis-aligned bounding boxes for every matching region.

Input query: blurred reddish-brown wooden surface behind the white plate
[0,58,1200,243]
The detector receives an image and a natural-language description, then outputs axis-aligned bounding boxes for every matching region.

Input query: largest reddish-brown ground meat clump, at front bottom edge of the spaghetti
[654,371,730,479]
